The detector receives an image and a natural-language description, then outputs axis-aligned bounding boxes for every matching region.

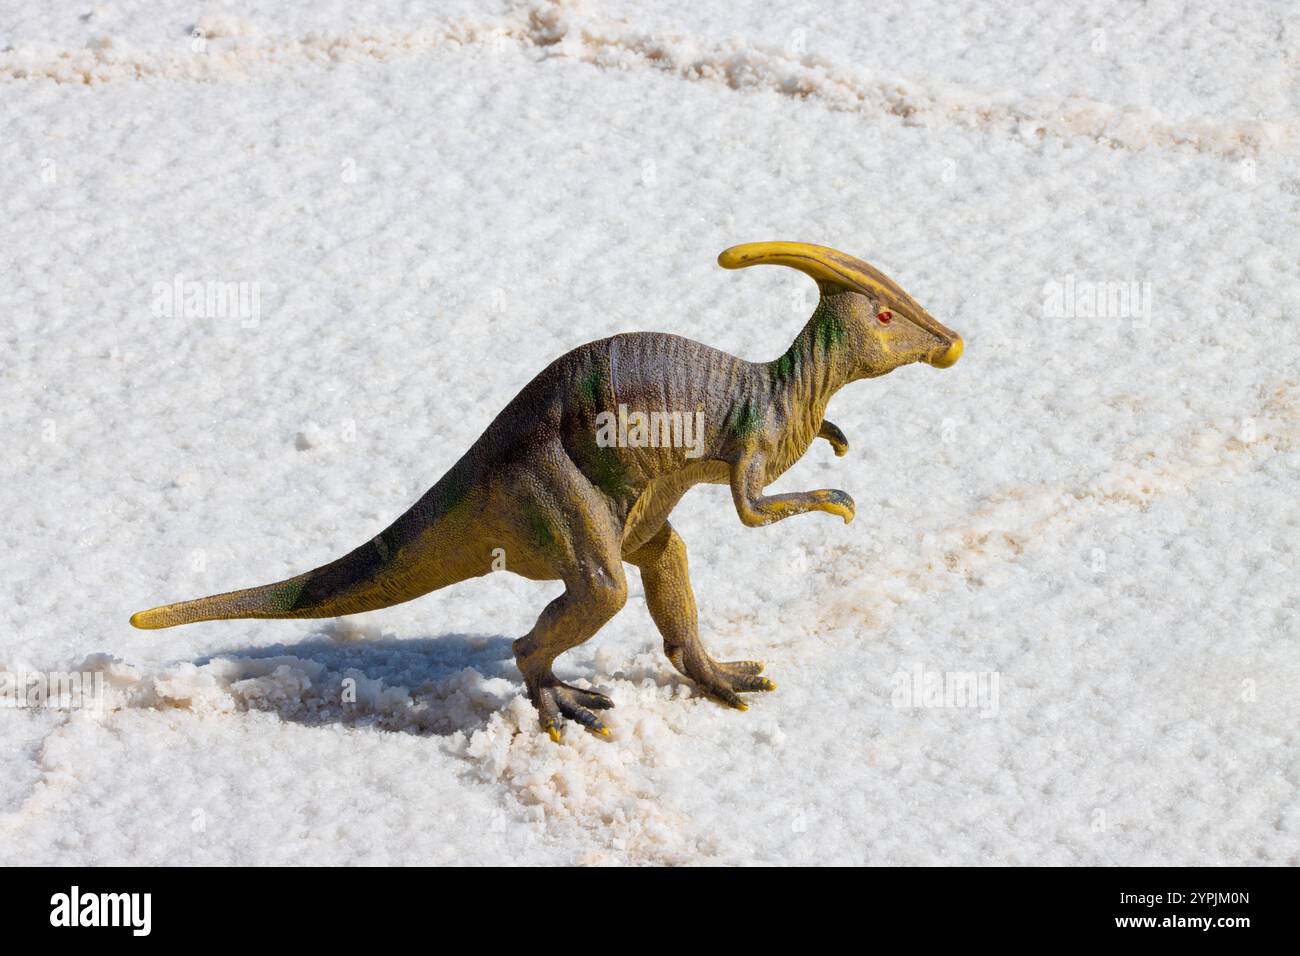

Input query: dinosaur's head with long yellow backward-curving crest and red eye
[718,242,962,378]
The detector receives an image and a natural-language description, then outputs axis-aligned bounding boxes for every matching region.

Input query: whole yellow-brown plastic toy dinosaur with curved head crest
[131,242,962,741]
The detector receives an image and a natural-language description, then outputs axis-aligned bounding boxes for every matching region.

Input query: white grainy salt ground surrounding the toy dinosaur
[0,0,1300,864]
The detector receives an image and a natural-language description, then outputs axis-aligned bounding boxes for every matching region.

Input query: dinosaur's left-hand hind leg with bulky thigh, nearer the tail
[510,455,628,743]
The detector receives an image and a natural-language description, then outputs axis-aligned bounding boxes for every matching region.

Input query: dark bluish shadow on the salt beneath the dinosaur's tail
[195,627,524,736]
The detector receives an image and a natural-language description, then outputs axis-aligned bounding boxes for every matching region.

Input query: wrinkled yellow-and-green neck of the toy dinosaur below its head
[767,306,853,454]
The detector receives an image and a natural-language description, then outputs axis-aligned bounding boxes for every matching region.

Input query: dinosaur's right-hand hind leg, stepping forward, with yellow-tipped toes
[628,522,776,710]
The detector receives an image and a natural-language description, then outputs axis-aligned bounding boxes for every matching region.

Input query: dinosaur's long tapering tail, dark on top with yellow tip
[131,470,489,630]
